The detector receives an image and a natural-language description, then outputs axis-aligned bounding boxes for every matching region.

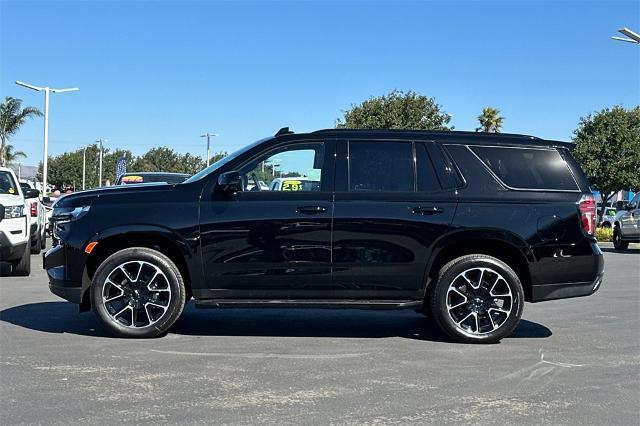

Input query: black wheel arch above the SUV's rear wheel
[424,229,535,301]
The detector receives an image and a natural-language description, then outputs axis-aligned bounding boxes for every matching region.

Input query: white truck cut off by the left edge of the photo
[0,167,34,275]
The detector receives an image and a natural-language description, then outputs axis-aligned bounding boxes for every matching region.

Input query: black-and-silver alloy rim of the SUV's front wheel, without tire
[102,261,172,328]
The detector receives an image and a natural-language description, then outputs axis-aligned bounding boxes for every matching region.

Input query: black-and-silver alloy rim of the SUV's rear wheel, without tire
[447,267,514,335]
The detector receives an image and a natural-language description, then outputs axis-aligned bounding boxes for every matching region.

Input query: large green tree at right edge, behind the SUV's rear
[573,106,640,221]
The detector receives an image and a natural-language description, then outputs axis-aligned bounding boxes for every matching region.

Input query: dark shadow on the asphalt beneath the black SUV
[0,302,552,342]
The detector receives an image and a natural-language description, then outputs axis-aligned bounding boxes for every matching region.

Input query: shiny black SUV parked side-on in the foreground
[44,128,604,343]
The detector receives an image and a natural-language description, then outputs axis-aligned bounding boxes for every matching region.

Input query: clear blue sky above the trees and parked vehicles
[0,0,640,165]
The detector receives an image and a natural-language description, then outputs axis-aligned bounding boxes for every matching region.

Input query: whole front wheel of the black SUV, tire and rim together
[91,247,186,338]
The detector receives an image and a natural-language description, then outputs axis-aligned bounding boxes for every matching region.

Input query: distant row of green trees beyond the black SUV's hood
[39,145,227,190]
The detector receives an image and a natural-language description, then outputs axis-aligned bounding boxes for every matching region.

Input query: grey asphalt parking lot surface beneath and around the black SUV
[0,245,640,425]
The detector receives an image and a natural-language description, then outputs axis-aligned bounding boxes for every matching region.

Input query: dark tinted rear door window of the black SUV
[349,141,414,192]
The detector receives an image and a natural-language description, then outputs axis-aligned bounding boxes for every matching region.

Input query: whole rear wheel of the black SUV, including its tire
[431,254,524,343]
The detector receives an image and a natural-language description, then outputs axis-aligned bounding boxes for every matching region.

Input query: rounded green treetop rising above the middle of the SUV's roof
[336,90,453,130]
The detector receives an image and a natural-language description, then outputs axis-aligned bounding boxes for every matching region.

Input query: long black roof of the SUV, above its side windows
[275,128,574,147]
